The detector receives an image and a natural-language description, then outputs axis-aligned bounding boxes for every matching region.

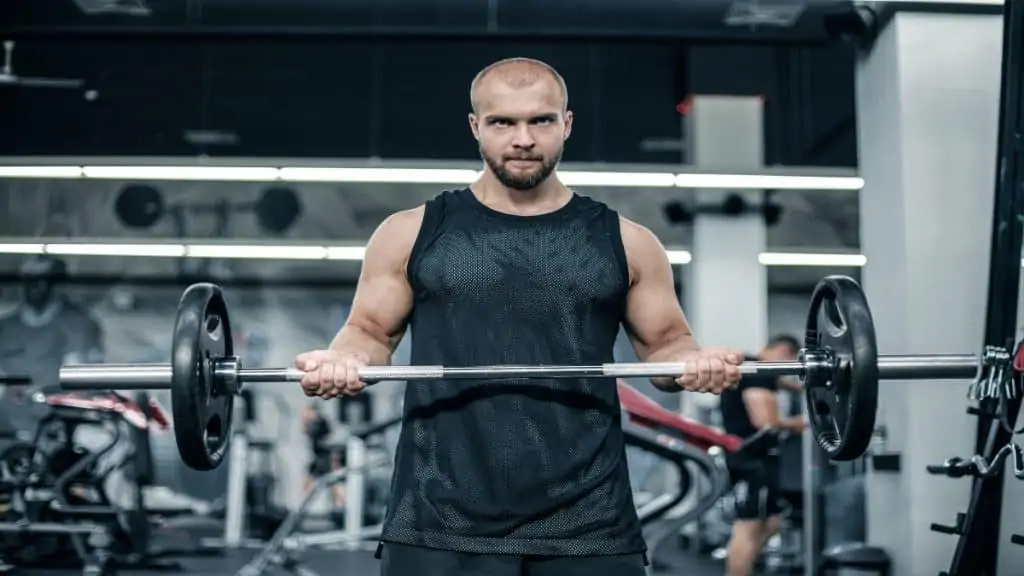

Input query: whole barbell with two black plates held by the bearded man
[59,276,1010,470]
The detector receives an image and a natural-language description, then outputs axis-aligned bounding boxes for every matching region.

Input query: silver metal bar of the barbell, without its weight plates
[60,354,981,394]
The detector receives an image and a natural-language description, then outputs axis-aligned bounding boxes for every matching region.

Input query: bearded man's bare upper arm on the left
[346,210,422,343]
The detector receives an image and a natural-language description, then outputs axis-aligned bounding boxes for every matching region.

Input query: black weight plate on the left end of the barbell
[171,284,234,470]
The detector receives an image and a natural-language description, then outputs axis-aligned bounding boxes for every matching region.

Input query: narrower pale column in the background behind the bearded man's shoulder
[684,96,768,416]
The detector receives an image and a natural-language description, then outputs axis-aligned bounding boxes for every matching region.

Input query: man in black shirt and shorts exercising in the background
[721,335,807,576]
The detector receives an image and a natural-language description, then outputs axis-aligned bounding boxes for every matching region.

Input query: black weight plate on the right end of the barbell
[804,276,879,461]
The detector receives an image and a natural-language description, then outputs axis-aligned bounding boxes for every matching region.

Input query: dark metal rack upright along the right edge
[948,0,1024,576]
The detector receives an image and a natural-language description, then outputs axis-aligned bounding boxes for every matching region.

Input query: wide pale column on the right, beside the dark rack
[856,12,999,575]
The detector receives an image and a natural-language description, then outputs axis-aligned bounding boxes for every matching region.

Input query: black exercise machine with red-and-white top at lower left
[0,392,174,576]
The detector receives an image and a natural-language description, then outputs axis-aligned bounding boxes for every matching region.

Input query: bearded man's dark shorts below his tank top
[379,543,647,576]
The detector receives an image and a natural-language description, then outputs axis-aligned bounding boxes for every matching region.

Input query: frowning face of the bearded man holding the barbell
[470,77,572,191]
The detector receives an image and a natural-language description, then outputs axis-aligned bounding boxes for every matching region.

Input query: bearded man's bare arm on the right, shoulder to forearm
[621,218,699,392]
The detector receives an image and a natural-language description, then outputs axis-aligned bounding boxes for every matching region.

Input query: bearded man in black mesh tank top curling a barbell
[296,58,742,576]
